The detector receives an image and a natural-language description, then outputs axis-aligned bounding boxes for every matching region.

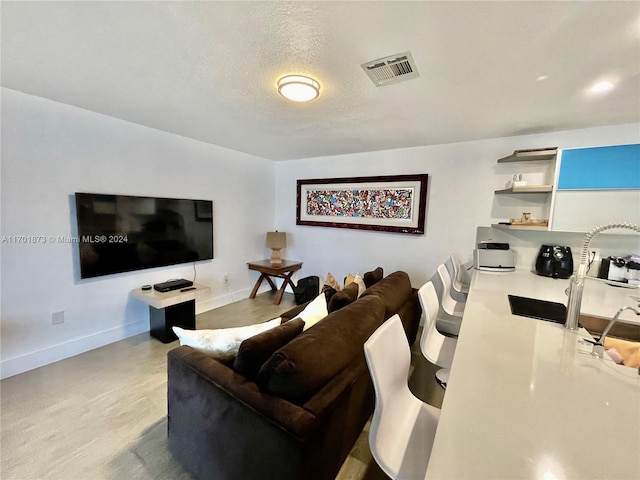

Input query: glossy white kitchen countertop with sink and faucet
[426,271,640,480]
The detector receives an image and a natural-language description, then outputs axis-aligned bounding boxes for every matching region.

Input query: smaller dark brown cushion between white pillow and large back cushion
[233,318,304,378]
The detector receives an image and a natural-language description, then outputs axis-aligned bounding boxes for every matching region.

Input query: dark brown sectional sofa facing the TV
[168,271,422,480]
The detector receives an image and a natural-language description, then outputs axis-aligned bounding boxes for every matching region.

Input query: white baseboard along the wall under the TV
[0,286,269,379]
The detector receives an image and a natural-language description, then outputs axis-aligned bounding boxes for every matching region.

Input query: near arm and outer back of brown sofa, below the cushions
[168,347,373,480]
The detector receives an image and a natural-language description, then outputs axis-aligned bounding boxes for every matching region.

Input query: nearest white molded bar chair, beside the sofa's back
[364,315,440,480]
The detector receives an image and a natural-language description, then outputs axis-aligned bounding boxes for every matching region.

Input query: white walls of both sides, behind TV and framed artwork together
[0,88,639,378]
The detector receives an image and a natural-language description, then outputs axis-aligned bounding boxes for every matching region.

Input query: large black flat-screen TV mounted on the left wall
[75,193,213,278]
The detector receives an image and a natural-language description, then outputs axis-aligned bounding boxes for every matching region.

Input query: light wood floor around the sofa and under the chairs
[0,292,444,480]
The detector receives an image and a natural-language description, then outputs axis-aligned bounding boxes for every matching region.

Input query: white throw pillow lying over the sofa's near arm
[171,317,282,360]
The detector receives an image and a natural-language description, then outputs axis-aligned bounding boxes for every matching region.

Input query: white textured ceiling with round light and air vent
[1,1,640,160]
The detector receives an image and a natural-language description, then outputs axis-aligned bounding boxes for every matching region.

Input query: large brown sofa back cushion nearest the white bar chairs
[256,295,385,402]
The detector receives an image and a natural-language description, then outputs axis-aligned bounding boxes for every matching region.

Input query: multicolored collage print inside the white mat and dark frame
[306,188,413,219]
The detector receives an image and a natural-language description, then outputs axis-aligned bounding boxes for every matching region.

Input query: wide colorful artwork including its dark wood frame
[296,174,429,235]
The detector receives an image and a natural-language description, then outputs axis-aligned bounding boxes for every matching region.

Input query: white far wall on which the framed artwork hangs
[275,124,640,286]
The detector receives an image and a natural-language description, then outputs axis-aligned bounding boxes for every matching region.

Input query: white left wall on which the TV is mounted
[0,88,274,377]
